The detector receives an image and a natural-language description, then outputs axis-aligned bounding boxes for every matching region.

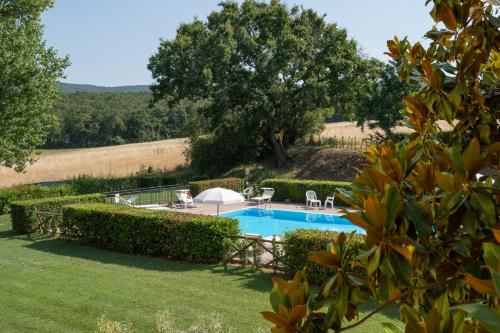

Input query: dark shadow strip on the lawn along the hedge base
[23,234,272,292]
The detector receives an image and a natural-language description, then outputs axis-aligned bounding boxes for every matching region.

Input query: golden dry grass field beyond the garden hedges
[0,122,452,187]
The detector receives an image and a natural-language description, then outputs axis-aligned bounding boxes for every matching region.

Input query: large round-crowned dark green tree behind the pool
[148,0,376,164]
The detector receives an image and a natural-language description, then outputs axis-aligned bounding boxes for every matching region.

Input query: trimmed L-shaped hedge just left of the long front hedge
[10,194,105,234]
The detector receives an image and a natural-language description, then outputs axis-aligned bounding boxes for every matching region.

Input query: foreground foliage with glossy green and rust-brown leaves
[264,0,500,333]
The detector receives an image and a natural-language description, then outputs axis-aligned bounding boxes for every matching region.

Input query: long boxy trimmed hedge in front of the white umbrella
[60,204,239,262]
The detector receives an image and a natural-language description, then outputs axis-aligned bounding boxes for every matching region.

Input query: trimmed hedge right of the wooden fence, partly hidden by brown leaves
[283,229,364,285]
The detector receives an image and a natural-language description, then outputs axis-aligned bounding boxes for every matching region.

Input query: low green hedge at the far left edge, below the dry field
[0,184,75,215]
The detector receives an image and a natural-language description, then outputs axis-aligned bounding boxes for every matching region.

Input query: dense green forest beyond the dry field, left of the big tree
[44,92,204,148]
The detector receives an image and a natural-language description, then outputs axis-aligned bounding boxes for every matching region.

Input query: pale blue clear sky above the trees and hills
[42,0,433,86]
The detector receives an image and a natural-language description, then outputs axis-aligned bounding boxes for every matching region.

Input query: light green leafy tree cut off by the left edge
[0,0,69,171]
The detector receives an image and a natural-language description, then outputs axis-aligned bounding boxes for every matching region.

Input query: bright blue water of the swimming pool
[220,208,365,237]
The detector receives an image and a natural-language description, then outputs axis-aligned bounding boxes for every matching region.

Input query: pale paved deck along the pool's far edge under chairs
[162,201,345,215]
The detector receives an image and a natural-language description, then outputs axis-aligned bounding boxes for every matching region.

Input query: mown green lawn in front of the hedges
[0,216,395,333]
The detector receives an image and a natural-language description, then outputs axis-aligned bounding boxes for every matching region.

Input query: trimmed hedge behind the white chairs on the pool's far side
[260,178,351,205]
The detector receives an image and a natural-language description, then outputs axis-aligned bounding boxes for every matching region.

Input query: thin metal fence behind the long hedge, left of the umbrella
[103,184,189,206]
